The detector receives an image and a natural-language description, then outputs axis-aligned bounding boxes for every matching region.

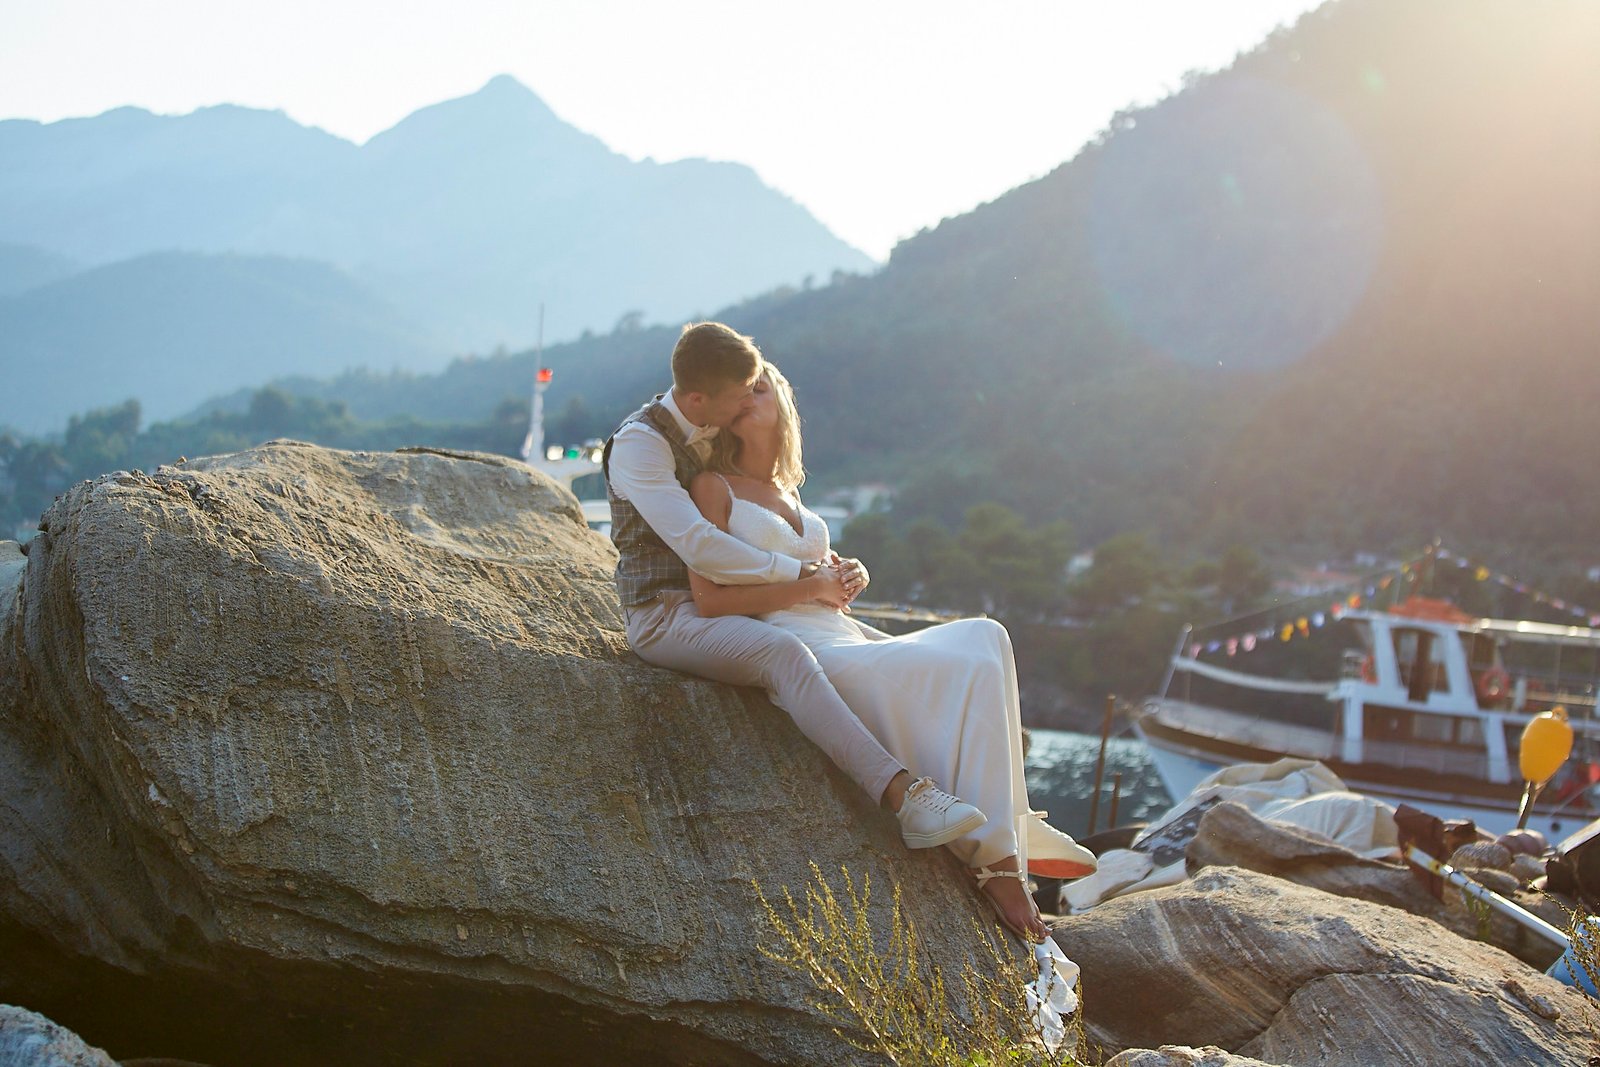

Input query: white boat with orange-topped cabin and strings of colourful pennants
[1134,597,1600,841]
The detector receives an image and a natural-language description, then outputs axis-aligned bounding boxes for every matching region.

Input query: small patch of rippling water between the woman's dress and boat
[1026,729,1173,838]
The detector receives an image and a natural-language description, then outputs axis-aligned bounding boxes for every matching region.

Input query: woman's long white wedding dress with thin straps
[728,486,1029,870]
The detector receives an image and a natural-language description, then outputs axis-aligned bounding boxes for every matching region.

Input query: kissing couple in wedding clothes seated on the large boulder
[603,322,1096,942]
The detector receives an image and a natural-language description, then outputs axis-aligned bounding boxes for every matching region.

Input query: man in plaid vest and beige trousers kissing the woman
[603,323,984,848]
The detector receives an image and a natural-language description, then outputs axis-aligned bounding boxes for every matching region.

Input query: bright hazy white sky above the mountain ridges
[0,0,1317,259]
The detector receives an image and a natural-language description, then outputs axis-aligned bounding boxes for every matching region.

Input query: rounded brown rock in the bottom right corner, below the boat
[1056,867,1600,1067]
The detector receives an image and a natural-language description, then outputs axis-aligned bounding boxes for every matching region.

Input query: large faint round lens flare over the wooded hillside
[1088,77,1384,370]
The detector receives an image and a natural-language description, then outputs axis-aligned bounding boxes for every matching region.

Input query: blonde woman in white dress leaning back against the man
[690,363,1096,941]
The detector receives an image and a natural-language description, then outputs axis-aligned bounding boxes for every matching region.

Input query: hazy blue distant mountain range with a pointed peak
[0,75,874,432]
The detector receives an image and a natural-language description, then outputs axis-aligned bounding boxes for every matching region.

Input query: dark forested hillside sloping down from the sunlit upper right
[219,0,1600,560]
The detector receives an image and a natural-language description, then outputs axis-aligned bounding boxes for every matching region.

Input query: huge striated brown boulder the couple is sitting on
[0,442,987,1064]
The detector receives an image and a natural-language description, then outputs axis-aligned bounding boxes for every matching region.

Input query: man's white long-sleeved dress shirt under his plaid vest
[611,389,800,585]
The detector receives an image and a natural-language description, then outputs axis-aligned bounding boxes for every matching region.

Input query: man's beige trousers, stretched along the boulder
[627,592,906,803]
